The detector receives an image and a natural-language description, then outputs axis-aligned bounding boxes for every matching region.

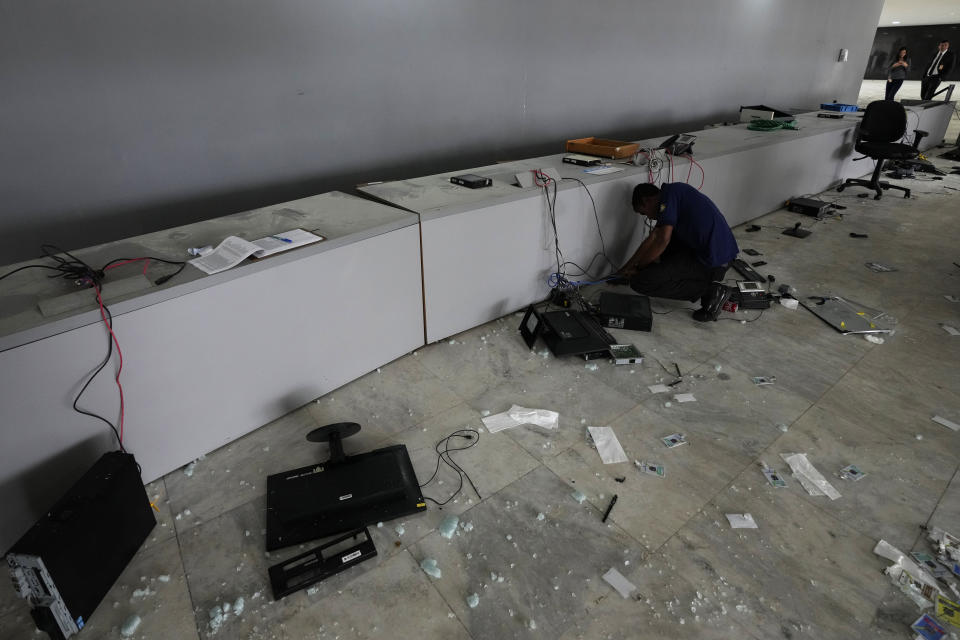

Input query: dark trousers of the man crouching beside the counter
[630,242,730,302]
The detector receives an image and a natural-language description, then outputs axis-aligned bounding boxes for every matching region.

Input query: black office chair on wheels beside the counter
[837,100,927,200]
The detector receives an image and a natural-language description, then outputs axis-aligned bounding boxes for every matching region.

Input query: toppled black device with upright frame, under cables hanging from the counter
[520,305,617,357]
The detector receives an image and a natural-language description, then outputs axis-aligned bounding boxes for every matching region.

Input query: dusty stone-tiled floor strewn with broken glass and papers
[0,151,960,640]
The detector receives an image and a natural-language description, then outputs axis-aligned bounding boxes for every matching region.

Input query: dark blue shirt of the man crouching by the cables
[657,182,740,267]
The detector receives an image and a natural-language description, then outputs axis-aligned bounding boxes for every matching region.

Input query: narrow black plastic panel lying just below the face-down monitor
[269,527,377,600]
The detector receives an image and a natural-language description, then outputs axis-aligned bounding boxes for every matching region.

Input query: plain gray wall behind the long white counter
[0,0,883,264]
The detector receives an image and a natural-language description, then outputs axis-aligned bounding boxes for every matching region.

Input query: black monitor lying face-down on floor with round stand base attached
[267,422,427,551]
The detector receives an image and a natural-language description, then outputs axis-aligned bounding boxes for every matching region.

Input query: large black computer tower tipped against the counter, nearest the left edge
[6,451,157,639]
